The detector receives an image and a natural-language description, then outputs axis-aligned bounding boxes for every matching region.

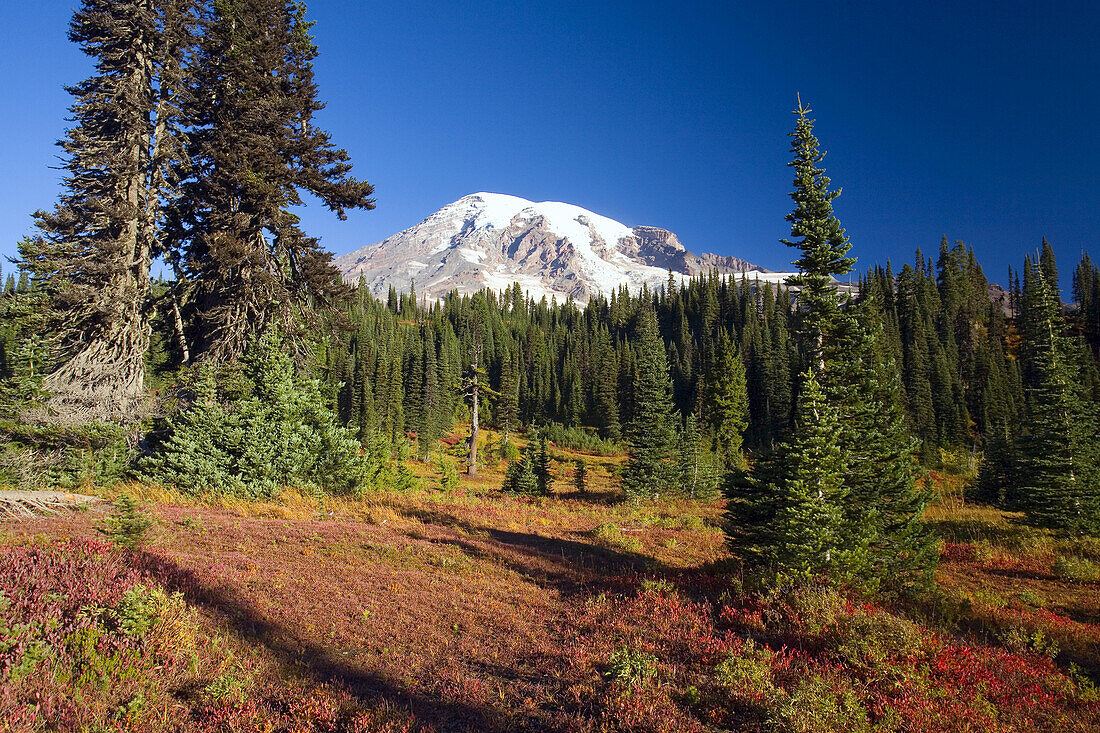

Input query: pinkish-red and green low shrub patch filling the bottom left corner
[0,540,200,731]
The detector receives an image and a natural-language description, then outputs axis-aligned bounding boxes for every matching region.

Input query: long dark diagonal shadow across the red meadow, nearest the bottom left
[139,553,565,732]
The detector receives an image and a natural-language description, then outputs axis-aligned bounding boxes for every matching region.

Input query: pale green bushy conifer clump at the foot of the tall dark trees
[141,332,374,499]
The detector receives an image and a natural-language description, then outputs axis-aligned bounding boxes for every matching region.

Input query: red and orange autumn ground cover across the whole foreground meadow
[0,484,1100,733]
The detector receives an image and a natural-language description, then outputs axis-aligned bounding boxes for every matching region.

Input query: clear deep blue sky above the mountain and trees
[0,0,1100,282]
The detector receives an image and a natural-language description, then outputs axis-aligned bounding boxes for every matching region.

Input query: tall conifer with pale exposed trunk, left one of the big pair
[20,0,193,422]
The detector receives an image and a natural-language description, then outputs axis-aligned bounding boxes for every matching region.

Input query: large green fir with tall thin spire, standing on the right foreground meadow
[727,101,934,589]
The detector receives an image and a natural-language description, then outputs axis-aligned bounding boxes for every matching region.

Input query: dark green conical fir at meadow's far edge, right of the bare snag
[623,304,677,499]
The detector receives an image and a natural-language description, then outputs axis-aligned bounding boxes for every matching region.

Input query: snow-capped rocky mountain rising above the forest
[336,193,790,303]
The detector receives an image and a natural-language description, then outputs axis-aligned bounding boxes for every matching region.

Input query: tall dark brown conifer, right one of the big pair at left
[169,0,374,361]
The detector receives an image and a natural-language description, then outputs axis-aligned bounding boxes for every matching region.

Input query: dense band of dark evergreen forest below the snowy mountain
[316,238,1100,464]
